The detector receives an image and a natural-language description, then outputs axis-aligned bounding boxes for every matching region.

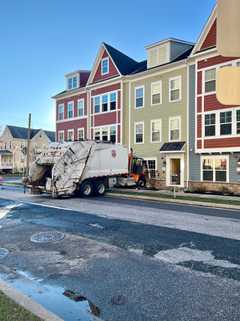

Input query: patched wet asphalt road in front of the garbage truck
[0,188,240,321]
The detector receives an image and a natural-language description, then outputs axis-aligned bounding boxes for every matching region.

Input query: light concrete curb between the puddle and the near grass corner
[0,281,64,321]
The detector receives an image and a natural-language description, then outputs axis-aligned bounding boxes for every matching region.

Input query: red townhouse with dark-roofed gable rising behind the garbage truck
[53,43,138,143]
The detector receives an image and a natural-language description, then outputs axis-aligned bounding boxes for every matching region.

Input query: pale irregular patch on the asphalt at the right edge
[154,247,240,269]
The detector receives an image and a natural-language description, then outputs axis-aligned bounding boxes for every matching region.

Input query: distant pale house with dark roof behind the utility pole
[0,125,55,173]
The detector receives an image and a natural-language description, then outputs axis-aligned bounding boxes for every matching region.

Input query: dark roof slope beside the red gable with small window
[103,42,139,75]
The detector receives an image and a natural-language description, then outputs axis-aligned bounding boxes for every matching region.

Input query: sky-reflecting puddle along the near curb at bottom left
[0,271,100,321]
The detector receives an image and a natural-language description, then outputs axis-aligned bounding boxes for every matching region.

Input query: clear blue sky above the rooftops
[0,0,215,130]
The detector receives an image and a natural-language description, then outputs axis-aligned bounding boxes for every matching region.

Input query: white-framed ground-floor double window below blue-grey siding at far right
[202,156,228,182]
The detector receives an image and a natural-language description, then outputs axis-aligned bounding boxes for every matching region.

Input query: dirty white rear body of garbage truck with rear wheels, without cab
[24,141,128,198]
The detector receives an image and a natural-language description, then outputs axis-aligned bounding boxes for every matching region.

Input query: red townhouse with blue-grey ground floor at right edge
[189,8,240,192]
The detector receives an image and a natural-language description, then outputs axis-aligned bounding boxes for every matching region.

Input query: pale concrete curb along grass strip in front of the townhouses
[106,192,240,210]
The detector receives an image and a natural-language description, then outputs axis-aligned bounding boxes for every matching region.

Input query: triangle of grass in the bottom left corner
[0,291,42,321]
